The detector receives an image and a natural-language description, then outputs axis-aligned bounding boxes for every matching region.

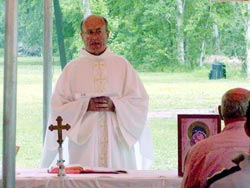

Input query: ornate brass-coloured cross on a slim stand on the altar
[49,116,70,176]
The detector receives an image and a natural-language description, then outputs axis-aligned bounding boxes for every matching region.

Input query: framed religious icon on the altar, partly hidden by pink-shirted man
[178,114,221,176]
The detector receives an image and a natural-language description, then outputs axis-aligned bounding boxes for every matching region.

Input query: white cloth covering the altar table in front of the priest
[0,169,182,188]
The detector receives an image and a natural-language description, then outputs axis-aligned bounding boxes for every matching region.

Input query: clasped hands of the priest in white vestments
[87,96,115,112]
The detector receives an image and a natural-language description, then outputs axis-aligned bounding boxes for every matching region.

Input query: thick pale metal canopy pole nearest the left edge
[2,0,18,188]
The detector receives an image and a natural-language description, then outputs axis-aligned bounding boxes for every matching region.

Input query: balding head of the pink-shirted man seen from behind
[221,88,250,120]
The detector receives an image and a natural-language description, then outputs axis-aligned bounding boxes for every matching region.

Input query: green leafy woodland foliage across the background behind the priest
[0,0,247,71]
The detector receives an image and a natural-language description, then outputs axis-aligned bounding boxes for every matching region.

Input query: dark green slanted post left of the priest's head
[53,0,67,69]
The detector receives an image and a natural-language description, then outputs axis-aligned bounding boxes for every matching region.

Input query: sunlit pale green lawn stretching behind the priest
[0,59,249,169]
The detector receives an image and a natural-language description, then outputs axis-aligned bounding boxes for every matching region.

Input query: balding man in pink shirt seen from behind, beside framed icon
[182,88,250,188]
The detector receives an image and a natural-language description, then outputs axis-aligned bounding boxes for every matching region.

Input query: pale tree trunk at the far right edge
[246,2,250,78]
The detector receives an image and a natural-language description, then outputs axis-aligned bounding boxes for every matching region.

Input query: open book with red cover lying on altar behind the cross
[48,165,127,174]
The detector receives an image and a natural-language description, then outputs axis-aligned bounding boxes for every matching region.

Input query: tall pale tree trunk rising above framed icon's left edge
[177,0,185,64]
